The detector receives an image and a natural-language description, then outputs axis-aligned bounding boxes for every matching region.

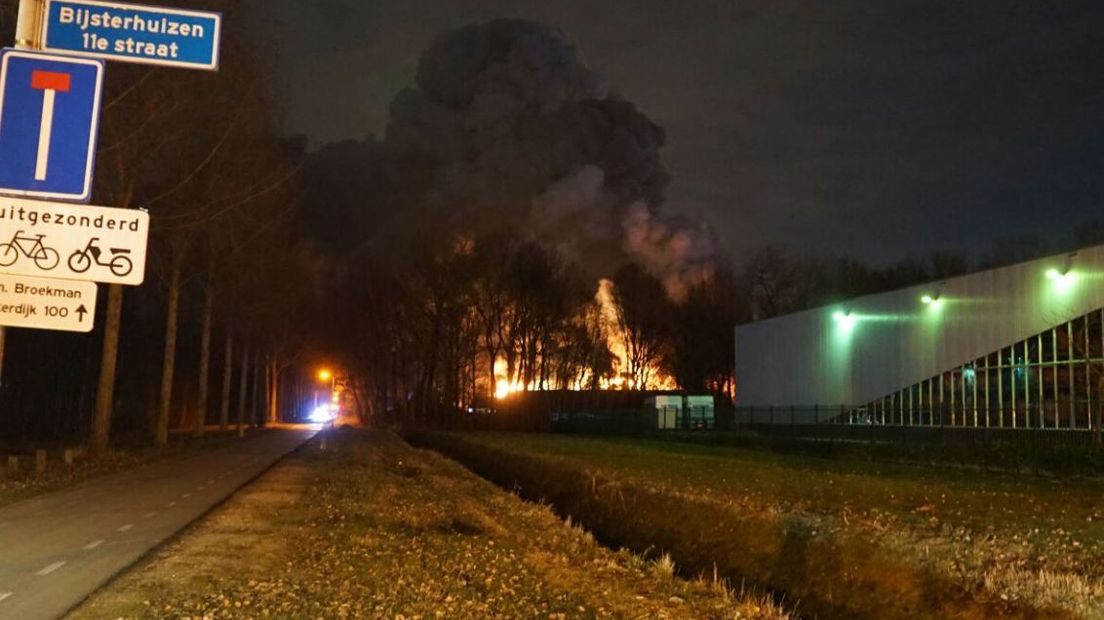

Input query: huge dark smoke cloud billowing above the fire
[385,20,714,297]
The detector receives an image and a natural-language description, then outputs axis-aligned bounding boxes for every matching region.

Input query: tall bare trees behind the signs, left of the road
[0,0,314,450]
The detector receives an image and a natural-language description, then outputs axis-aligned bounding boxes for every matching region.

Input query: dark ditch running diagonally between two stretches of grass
[407,434,1078,620]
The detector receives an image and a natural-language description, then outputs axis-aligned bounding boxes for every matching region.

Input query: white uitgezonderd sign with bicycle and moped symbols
[0,197,149,286]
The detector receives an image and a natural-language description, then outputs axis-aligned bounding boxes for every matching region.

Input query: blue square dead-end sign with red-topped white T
[0,50,104,202]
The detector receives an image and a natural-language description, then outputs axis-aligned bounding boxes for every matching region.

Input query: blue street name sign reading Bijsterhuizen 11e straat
[43,0,222,71]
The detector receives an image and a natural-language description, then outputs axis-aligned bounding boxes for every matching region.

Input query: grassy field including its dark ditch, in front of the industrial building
[416,434,1104,619]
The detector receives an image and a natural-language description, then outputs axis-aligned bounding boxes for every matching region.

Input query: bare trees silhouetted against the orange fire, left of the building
[328,233,737,423]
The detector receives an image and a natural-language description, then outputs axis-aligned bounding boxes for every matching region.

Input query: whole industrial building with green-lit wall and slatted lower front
[735,246,1104,429]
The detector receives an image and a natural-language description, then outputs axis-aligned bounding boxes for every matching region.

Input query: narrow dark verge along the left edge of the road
[0,430,270,506]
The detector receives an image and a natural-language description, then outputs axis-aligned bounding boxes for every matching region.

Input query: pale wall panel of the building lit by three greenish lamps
[736,246,1104,407]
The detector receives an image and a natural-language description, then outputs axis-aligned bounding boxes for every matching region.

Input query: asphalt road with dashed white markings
[0,429,315,620]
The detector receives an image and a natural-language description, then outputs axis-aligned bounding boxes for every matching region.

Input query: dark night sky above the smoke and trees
[250,0,1104,263]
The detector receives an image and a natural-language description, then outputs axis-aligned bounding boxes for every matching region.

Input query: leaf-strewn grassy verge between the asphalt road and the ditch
[72,430,785,619]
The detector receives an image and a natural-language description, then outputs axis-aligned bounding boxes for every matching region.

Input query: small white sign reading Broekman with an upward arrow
[0,274,96,333]
